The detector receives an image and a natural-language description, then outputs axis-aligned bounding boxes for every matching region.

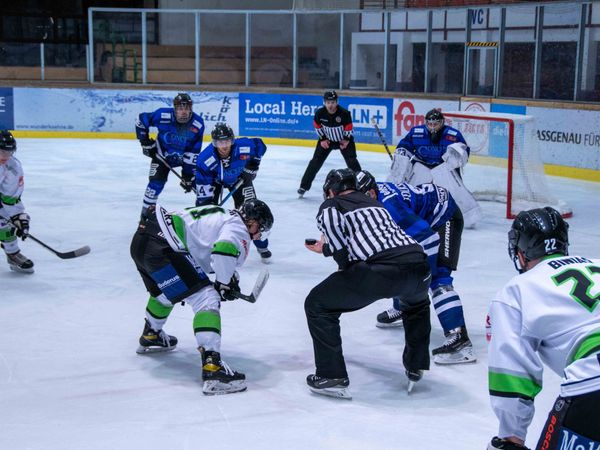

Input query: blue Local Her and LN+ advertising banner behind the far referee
[239,93,393,144]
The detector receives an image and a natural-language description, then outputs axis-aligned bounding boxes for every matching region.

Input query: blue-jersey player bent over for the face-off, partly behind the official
[357,171,476,364]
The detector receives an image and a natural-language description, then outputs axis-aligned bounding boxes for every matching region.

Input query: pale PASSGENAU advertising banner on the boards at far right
[527,106,600,170]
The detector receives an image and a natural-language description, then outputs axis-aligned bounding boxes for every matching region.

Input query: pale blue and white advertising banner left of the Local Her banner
[14,88,238,134]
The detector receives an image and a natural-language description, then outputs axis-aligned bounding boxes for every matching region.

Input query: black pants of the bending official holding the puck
[304,253,431,378]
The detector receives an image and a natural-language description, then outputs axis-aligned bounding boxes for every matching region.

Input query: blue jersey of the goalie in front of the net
[396,125,470,167]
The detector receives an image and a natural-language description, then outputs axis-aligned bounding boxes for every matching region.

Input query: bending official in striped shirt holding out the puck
[304,169,431,398]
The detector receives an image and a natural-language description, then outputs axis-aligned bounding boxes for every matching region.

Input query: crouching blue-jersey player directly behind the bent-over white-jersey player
[195,123,271,263]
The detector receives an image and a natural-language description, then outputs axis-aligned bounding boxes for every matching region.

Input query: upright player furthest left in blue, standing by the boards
[135,93,204,218]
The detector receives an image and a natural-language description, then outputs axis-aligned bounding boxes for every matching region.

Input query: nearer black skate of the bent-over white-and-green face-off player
[199,347,247,395]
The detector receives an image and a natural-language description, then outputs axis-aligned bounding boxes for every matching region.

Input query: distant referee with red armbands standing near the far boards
[298,91,361,198]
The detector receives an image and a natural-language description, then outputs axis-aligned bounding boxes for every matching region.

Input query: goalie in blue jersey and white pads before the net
[388,109,481,228]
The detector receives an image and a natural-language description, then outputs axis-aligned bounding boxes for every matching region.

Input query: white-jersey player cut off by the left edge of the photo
[0,130,33,273]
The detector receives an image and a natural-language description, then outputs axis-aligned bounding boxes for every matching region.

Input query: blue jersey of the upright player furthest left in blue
[135,108,204,175]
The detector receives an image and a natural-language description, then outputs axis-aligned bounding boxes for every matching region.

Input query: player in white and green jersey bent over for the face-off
[131,199,273,395]
